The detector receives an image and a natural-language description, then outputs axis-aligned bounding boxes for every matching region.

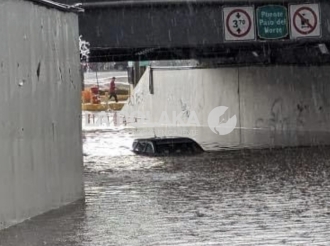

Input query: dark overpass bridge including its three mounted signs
[61,0,330,64]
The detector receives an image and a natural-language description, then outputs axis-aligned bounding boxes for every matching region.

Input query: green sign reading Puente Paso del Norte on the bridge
[256,5,288,39]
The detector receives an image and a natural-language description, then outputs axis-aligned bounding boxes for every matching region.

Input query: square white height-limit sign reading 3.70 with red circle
[223,7,255,41]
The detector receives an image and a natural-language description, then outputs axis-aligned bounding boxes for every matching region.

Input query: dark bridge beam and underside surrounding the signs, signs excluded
[62,0,330,65]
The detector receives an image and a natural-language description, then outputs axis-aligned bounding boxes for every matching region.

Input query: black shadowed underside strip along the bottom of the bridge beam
[89,42,330,65]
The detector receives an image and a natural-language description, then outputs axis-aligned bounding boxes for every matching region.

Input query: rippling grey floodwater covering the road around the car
[0,113,330,246]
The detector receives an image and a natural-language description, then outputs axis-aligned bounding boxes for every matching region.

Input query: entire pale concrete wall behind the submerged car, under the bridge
[122,66,330,149]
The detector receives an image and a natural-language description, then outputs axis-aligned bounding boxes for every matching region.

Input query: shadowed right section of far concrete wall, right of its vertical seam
[239,66,330,146]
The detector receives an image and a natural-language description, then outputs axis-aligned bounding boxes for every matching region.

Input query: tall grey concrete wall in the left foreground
[0,0,83,229]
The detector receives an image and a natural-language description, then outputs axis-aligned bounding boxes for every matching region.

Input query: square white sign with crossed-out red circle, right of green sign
[290,3,321,39]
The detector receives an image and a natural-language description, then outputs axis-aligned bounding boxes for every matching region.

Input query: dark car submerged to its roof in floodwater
[132,137,204,156]
